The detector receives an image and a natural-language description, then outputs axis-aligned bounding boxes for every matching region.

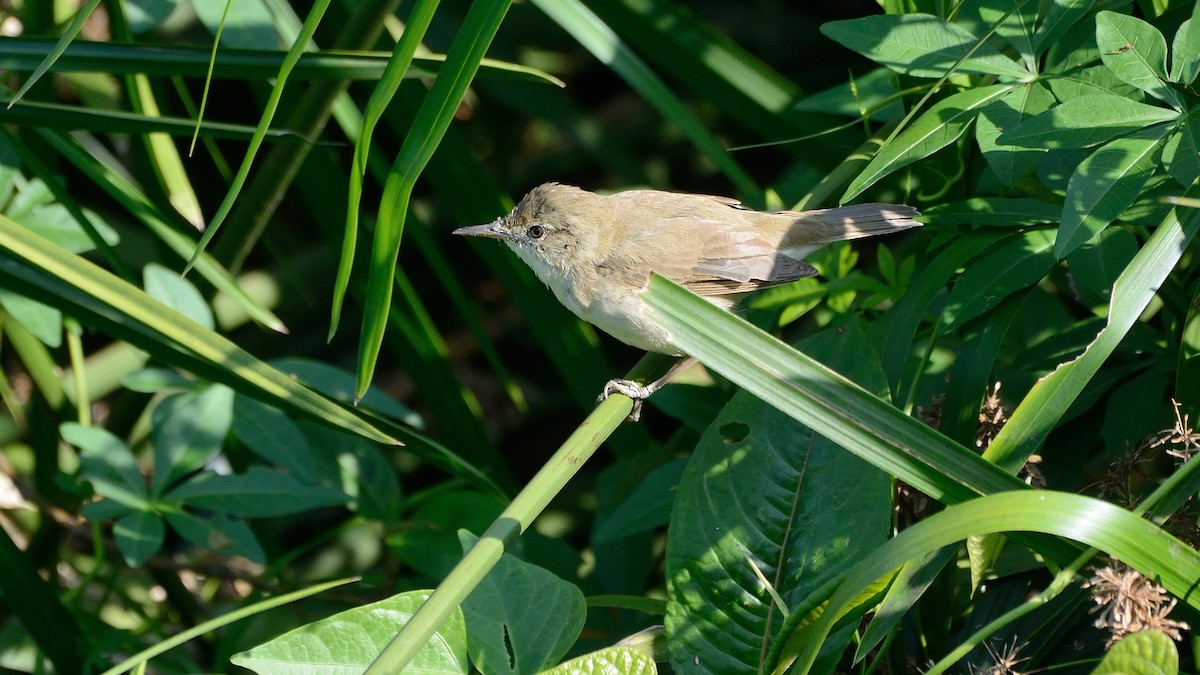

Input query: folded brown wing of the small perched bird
[644,217,817,295]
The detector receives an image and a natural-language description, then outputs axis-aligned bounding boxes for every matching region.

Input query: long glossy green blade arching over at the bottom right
[774,490,1200,673]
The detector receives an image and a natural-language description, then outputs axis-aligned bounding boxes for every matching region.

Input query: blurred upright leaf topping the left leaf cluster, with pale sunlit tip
[150,384,233,495]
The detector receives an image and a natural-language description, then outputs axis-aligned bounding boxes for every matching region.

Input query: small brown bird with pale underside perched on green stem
[455,183,920,415]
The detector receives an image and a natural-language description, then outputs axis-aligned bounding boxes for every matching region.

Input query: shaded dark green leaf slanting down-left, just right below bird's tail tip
[938,229,1057,335]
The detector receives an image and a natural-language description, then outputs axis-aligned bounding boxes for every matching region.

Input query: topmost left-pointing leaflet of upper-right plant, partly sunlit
[821,14,1030,80]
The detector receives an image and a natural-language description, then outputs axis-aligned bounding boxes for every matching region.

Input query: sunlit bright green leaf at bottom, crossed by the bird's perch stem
[229,591,469,675]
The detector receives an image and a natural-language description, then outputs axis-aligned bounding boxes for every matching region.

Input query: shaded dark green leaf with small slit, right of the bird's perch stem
[458,530,587,674]
